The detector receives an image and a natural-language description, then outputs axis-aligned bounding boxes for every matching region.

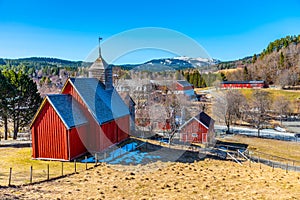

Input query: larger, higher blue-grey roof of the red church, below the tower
[69,78,129,124]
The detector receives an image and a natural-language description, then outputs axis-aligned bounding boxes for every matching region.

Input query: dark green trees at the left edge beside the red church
[0,70,42,140]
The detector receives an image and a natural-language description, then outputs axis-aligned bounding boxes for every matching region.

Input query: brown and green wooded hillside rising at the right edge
[219,35,300,87]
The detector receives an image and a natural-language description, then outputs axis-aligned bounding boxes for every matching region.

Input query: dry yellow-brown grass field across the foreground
[0,142,300,199]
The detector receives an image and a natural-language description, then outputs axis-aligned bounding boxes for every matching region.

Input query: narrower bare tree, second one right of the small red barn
[249,90,271,137]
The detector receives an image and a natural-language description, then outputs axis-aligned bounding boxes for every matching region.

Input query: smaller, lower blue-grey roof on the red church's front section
[46,94,88,129]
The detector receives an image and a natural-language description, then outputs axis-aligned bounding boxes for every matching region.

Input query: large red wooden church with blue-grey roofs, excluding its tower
[30,55,130,160]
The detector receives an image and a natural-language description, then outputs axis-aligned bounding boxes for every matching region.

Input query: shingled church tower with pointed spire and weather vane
[89,38,113,90]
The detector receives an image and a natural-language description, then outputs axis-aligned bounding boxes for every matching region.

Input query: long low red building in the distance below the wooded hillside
[220,81,268,89]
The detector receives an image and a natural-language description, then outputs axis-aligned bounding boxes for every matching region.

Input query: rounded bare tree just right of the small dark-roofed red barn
[213,90,246,133]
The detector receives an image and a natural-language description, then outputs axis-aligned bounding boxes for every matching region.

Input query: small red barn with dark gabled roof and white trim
[179,112,214,143]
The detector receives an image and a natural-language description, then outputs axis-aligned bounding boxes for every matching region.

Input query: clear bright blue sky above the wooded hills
[0,0,300,63]
